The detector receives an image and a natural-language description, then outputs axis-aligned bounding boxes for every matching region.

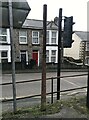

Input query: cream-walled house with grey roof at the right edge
[64,31,89,65]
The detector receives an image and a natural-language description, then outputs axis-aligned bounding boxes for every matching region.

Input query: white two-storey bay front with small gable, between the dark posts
[46,21,58,63]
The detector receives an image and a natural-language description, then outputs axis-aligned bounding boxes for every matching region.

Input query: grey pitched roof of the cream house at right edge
[75,31,89,41]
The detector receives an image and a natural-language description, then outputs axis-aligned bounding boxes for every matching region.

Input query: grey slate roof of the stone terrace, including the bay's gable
[22,19,58,30]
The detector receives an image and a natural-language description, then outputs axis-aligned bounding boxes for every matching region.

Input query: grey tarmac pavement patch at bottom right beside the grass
[1,94,89,120]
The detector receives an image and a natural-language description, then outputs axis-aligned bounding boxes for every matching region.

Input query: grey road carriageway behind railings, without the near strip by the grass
[2,72,87,99]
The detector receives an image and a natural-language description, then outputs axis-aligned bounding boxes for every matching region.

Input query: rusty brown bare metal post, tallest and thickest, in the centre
[41,5,47,110]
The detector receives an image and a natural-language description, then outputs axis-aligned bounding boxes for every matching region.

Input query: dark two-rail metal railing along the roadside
[0,74,88,103]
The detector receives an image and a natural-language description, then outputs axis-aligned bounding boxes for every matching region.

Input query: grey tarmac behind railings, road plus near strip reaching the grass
[1,72,87,111]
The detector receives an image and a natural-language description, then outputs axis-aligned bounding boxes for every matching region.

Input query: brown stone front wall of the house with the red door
[14,29,43,66]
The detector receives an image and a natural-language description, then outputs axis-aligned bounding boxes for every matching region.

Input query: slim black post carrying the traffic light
[57,8,62,100]
